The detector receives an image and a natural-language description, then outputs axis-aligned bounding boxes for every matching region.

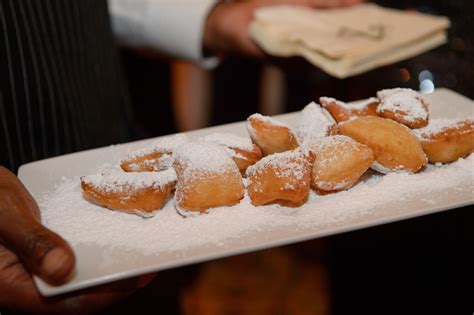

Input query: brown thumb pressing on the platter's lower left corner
[0,217,75,285]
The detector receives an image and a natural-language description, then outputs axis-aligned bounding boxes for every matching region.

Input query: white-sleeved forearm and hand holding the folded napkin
[108,0,362,65]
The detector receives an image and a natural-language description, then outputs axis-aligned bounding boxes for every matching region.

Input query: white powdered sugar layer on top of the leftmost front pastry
[81,168,176,192]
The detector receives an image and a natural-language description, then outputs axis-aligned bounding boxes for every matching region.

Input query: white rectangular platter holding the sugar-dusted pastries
[19,89,474,296]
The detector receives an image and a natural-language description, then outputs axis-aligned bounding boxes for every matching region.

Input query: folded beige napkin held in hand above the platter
[250,3,449,78]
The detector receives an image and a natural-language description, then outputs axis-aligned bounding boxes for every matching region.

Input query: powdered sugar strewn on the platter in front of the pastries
[40,155,474,255]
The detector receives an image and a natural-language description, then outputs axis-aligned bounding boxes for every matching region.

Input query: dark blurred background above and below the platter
[104,0,474,315]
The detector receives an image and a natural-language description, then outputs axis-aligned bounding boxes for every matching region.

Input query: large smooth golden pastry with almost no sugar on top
[339,116,428,173]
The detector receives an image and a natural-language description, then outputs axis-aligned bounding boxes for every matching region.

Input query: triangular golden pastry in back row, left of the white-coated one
[247,114,298,156]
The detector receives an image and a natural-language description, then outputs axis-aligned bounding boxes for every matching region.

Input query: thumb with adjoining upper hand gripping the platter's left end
[0,167,75,285]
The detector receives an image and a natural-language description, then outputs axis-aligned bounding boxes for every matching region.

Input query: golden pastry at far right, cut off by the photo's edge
[415,119,474,163]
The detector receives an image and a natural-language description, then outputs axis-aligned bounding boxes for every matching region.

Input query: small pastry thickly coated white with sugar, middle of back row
[296,102,337,143]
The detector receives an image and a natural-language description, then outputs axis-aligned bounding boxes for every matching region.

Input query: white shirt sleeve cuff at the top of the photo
[108,0,217,66]
